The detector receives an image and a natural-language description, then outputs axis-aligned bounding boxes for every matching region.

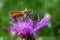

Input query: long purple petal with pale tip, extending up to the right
[34,14,50,31]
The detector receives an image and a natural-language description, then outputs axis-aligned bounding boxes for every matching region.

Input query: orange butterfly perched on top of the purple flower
[10,10,32,18]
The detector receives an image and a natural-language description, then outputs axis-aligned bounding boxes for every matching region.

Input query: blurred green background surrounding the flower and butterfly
[0,0,60,40]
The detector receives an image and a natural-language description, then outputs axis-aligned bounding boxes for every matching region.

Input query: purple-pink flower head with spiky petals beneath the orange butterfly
[7,14,50,37]
